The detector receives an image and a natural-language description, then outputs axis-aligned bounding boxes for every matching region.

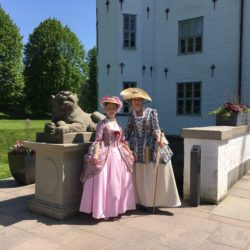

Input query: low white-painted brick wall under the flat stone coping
[183,133,250,202]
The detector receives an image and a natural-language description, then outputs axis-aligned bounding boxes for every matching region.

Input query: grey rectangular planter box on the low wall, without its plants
[216,112,250,126]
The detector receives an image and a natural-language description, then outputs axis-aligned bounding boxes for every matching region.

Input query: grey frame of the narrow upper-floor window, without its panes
[122,14,137,50]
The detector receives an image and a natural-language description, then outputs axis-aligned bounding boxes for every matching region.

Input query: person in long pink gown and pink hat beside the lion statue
[80,96,136,219]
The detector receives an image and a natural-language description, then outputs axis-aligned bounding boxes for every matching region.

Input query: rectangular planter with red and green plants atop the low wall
[208,102,250,126]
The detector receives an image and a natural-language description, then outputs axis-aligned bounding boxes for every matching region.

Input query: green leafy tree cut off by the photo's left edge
[0,6,23,108]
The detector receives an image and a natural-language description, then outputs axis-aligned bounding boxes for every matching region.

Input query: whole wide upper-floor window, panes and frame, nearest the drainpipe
[179,17,203,54]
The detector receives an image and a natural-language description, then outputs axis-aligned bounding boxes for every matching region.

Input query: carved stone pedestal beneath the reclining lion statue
[25,142,90,220]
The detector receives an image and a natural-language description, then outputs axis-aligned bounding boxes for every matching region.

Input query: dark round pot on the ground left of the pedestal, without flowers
[8,152,36,185]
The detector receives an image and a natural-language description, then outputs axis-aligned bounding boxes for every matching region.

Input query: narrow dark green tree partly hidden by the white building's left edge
[80,47,97,112]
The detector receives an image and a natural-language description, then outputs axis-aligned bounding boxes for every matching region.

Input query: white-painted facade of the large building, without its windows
[97,0,250,134]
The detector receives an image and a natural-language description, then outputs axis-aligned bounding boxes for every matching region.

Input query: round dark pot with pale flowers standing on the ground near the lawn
[8,119,36,185]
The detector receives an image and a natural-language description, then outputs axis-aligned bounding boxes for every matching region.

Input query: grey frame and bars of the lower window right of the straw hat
[176,81,202,117]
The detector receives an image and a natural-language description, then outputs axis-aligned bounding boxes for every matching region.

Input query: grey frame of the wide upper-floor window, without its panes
[177,16,204,55]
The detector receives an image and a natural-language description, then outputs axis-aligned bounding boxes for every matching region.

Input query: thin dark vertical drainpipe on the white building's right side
[238,0,244,103]
